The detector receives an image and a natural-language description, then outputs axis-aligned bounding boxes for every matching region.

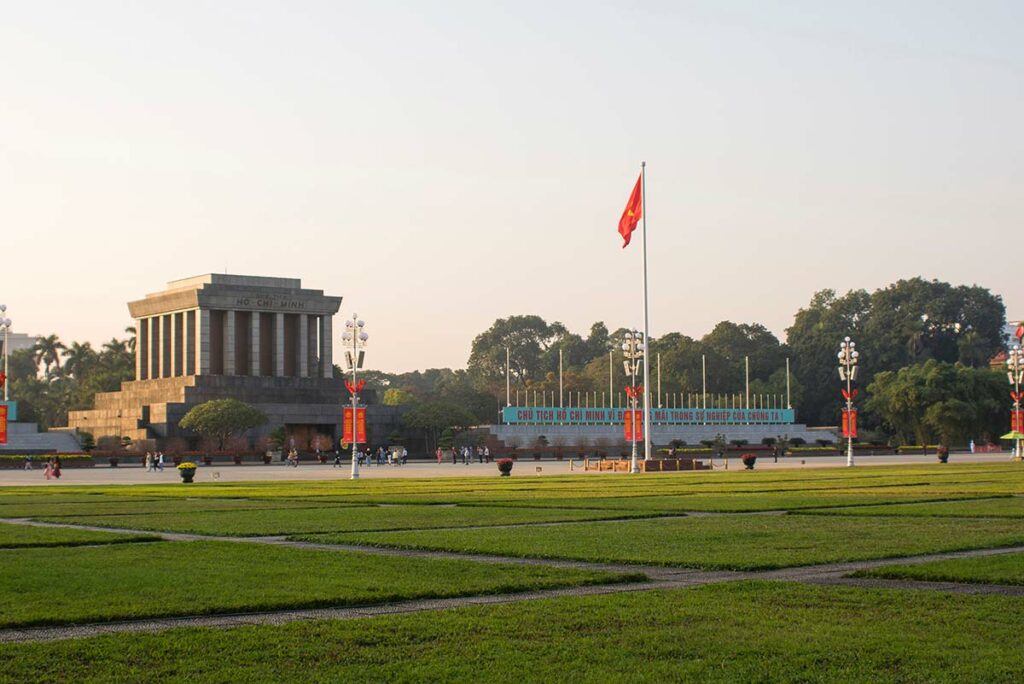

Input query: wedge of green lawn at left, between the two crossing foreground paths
[0,542,638,630]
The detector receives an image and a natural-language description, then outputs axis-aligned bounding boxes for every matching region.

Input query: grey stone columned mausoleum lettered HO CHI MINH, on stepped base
[68,273,358,440]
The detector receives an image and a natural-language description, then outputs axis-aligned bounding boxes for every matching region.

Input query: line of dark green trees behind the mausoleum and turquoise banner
[9,277,1009,443]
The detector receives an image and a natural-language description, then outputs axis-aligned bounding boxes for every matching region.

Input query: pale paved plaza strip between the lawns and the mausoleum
[0,453,1011,486]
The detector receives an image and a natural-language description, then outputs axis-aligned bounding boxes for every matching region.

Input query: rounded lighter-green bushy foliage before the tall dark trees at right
[865,358,1009,445]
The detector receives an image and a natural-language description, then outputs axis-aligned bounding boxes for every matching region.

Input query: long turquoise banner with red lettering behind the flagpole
[502,407,796,425]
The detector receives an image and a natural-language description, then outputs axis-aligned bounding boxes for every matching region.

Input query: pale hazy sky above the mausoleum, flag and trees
[0,0,1024,372]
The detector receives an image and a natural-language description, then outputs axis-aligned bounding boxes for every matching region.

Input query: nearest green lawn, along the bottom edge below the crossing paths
[0,583,1024,684]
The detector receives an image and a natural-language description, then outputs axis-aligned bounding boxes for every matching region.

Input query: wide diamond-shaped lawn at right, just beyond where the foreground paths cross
[300,515,1024,569]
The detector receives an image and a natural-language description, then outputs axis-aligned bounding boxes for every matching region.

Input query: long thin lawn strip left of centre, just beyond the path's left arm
[41,506,644,537]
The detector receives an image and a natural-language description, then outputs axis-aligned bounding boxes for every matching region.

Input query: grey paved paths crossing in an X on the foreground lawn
[0,518,1024,643]
